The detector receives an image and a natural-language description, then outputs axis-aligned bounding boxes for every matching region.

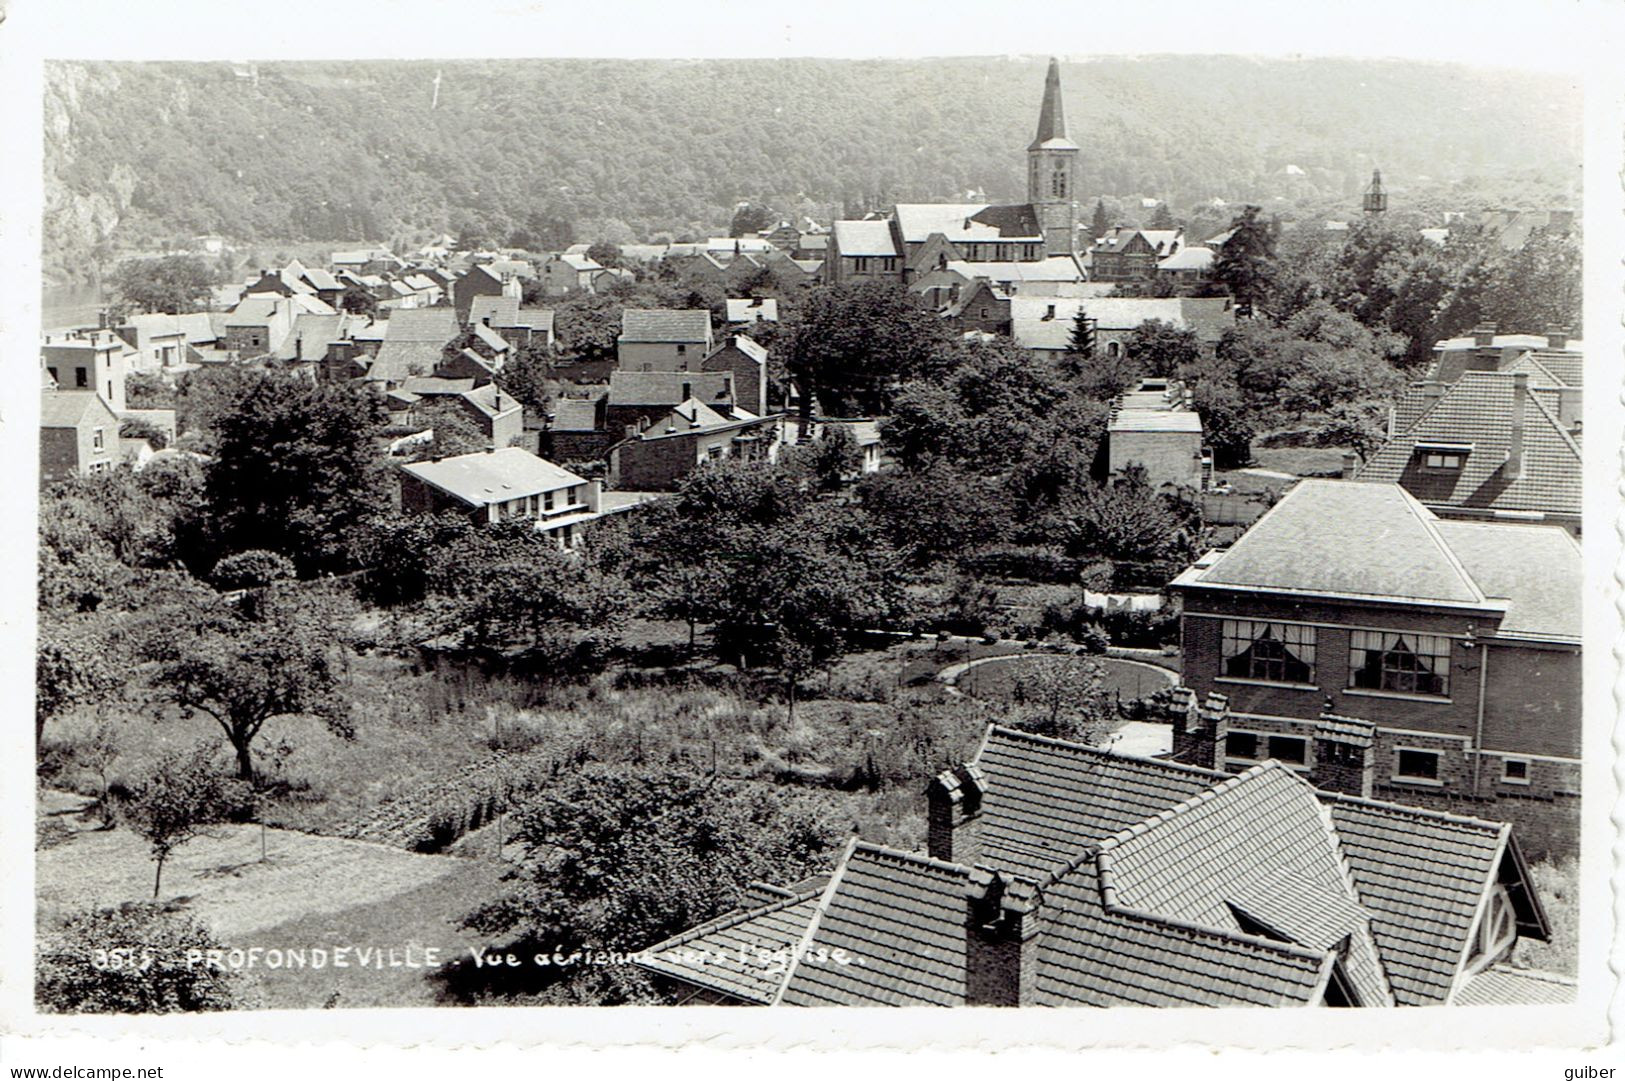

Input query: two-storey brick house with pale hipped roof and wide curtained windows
[1170,480,1583,857]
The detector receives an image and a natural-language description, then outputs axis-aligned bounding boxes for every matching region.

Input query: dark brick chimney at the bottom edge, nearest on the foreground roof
[965,866,1043,1006]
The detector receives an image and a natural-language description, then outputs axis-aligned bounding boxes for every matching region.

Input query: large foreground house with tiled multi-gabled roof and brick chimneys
[637,727,1573,1008]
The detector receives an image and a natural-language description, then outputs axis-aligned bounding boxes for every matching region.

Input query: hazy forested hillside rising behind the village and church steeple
[44,57,1581,276]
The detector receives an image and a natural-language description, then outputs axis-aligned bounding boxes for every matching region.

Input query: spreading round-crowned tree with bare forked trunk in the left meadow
[145,595,354,782]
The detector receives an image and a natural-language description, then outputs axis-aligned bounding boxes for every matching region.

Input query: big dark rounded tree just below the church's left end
[780,281,956,416]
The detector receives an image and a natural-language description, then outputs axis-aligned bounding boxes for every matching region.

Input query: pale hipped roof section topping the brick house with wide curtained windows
[1177,478,1497,608]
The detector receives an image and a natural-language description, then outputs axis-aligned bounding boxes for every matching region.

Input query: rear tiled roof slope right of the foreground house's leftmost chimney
[975,728,1225,876]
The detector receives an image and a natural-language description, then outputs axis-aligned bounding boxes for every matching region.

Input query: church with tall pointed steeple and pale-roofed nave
[824,59,1087,304]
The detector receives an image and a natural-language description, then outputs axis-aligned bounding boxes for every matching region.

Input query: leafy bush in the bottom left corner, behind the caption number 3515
[34,902,244,1014]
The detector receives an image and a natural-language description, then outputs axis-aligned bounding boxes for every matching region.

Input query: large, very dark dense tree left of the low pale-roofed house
[205,372,385,574]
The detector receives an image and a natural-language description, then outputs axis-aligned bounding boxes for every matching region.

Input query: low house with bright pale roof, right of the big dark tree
[400,447,601,548]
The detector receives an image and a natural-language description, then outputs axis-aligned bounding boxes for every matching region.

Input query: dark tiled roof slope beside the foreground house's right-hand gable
[1321,795,1510,1006]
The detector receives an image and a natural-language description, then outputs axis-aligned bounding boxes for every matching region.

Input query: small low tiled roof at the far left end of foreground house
[644,884,824,1006]
